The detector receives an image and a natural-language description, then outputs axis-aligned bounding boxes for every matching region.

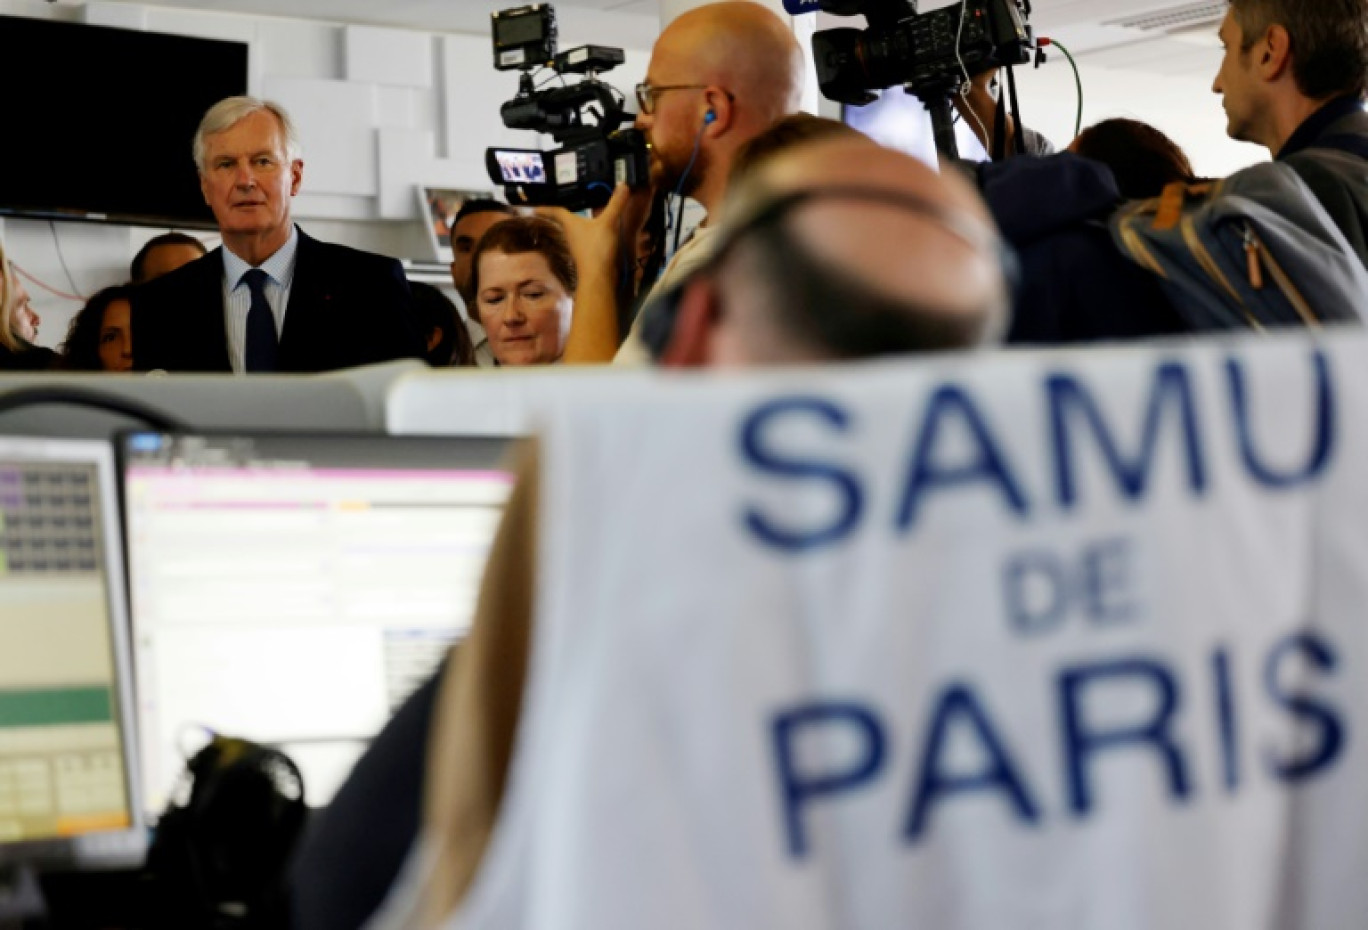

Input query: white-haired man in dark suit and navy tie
[133,97,423,373]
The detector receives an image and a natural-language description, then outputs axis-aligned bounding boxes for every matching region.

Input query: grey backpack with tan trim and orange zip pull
[1111,152,1368,331]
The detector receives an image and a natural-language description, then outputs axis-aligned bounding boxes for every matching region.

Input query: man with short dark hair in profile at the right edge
[1212,0,1368,264]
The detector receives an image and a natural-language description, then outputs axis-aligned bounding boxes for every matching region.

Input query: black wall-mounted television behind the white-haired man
[0,16,248,228]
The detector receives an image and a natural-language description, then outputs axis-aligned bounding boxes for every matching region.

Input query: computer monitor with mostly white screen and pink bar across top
[122,432,513,812]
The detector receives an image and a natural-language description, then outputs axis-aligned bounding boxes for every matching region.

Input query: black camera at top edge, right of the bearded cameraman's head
[813,0,1036,107]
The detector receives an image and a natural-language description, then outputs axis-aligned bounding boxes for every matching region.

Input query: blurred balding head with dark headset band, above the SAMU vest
[656,140,1008,365]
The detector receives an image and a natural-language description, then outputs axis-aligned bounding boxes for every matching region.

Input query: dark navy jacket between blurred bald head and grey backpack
[978,152,1186,345]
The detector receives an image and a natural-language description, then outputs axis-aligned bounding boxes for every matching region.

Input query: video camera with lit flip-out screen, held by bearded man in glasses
[484,4,650,211]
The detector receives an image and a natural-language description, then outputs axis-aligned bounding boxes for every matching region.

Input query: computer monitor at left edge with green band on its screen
[0,436,146,867]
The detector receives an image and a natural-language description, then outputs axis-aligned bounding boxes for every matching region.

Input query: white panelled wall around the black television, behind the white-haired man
[0,0,648,346]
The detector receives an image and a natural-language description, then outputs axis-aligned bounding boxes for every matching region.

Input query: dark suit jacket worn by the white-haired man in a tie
[131,230,424,372]
